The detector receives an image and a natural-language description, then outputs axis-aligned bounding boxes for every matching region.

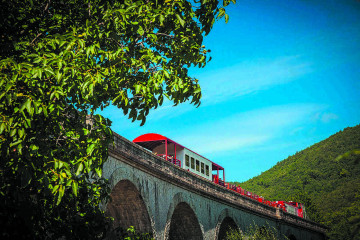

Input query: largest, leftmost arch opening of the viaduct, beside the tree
[105,180,153,239]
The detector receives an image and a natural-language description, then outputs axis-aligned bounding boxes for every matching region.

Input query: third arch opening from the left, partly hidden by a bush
[215,208,240,240]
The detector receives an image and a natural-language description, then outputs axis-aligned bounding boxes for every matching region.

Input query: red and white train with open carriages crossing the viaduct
[133,133,306,218]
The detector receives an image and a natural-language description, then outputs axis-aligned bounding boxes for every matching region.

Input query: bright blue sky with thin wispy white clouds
[102,0,360,181]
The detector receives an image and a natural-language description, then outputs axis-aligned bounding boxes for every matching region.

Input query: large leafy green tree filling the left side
[0,0,235,239]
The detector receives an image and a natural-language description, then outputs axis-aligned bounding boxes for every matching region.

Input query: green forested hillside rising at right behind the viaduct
[232,125,360,240]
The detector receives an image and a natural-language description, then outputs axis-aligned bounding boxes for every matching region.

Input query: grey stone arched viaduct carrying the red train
[104,133,326,240]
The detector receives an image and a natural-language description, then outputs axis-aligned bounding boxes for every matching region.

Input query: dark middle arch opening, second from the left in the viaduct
[166,202,203,240]
